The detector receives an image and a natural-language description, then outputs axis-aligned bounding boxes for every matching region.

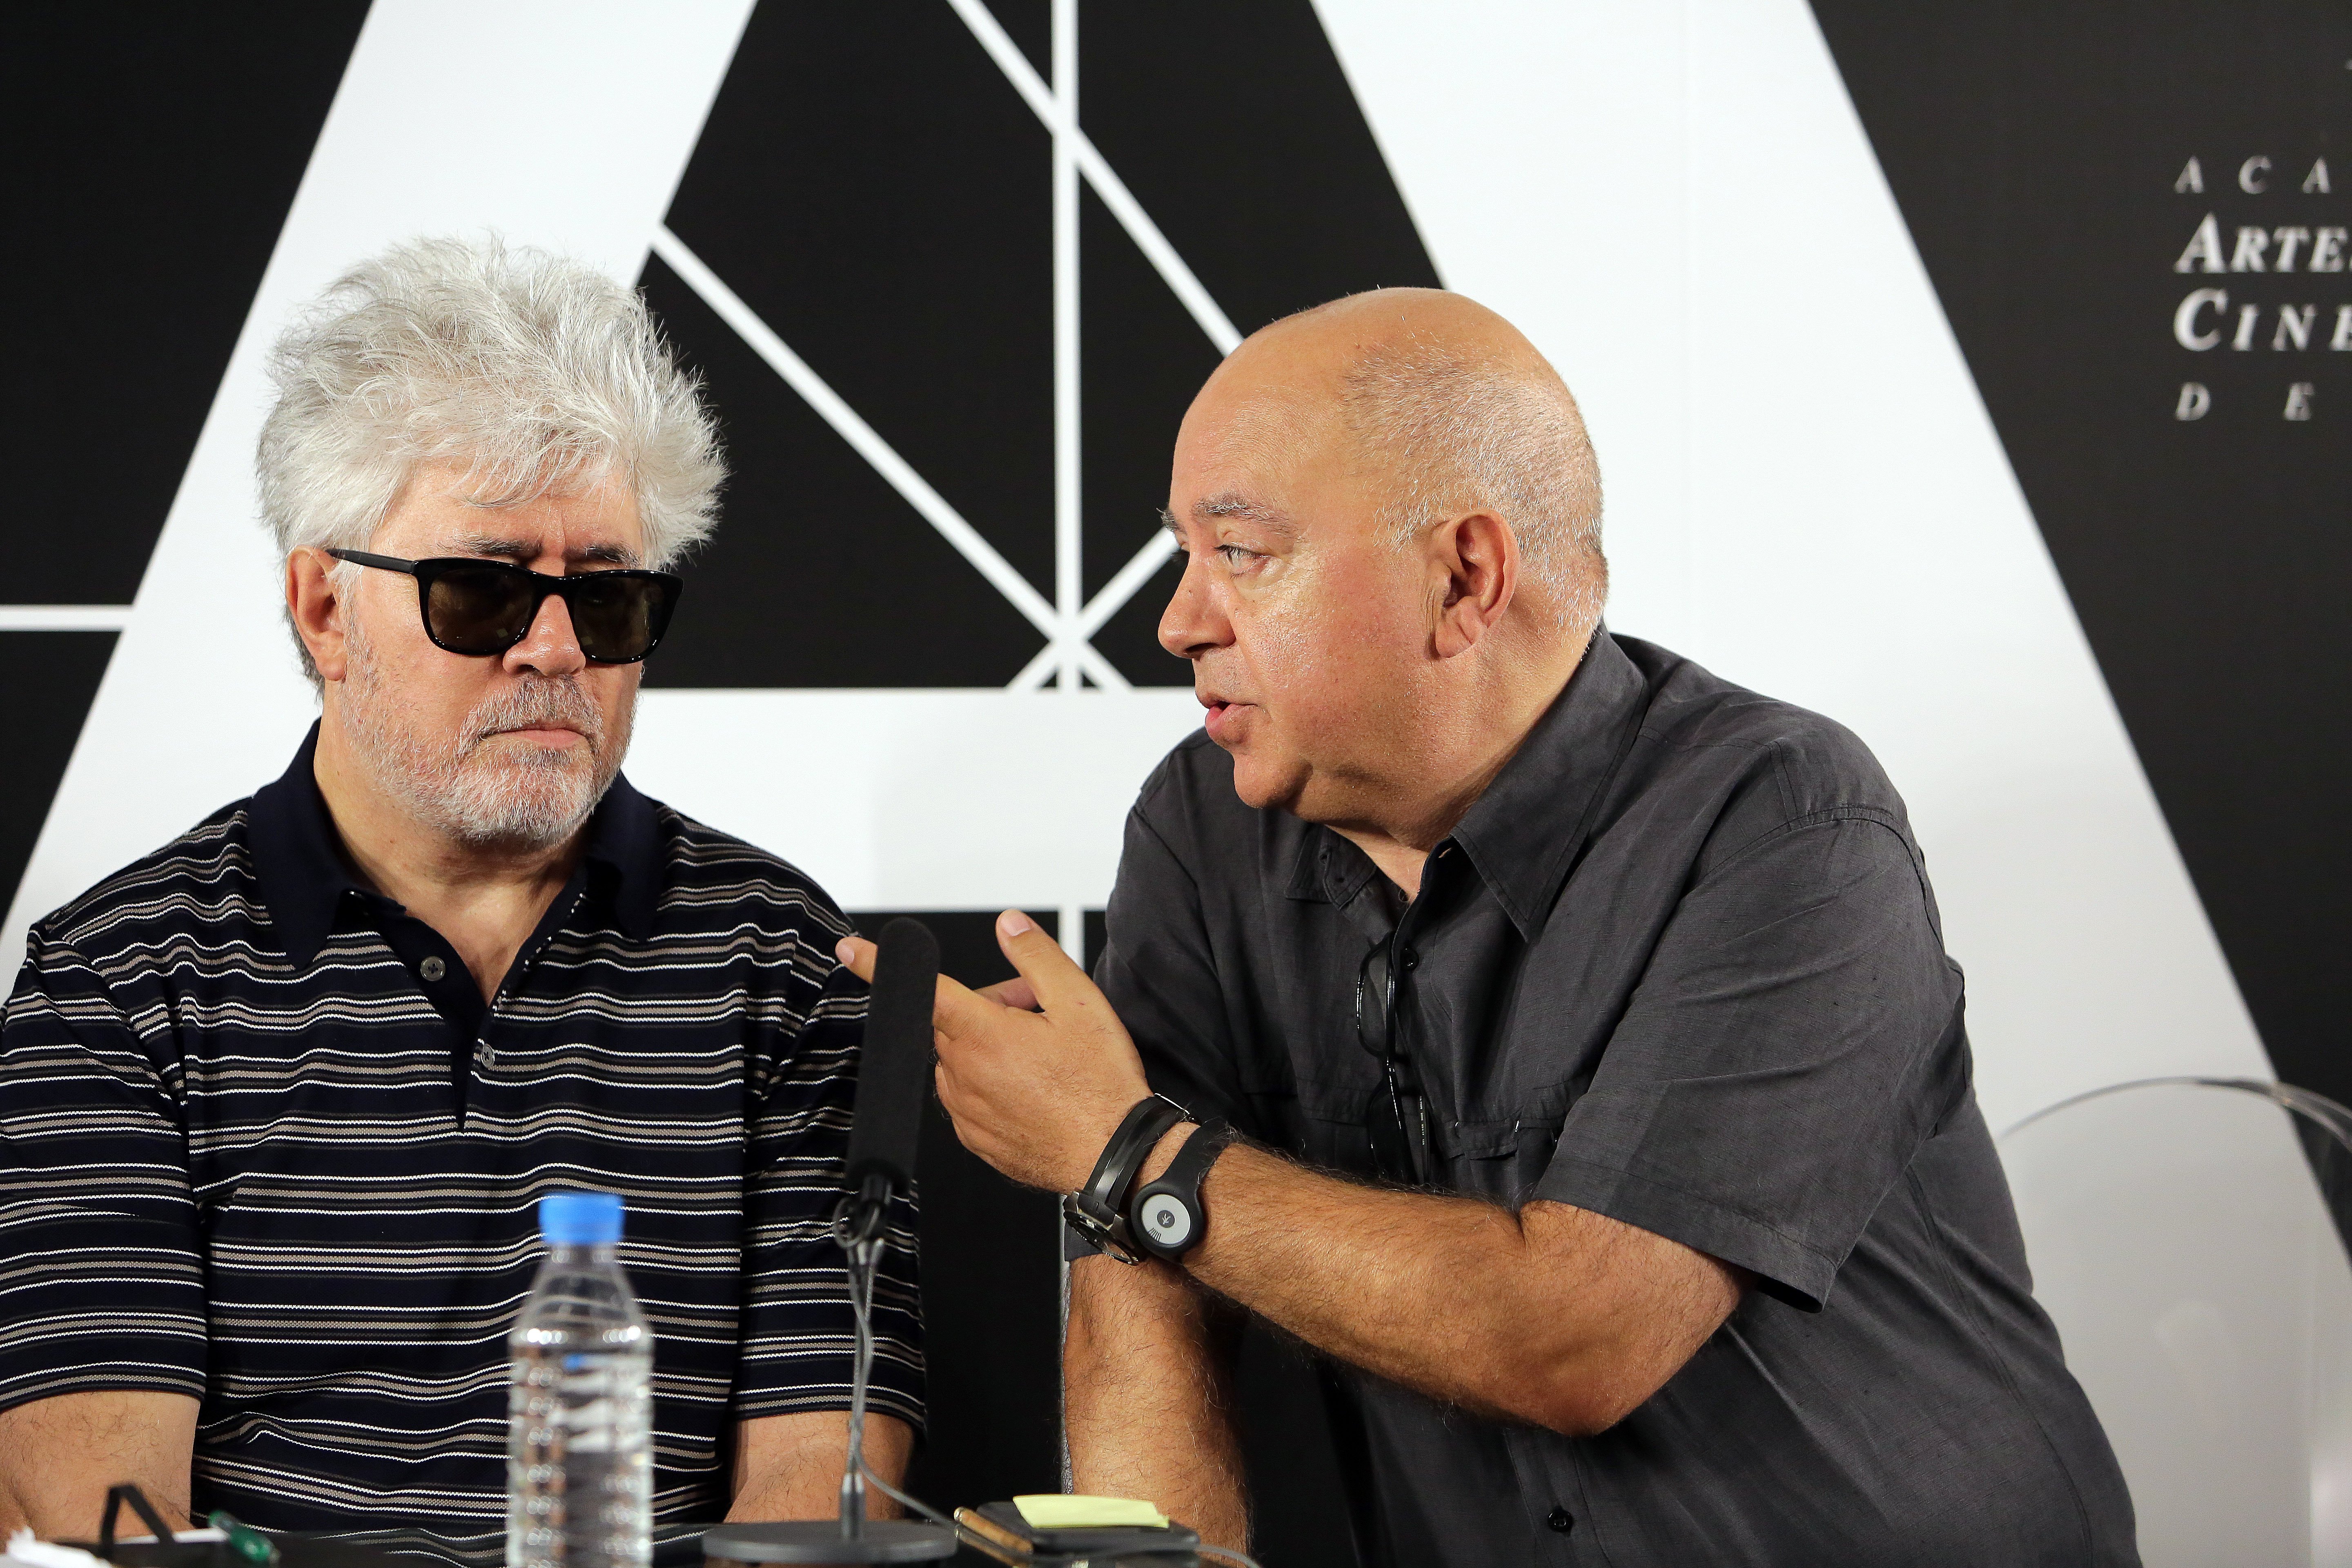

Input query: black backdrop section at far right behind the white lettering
[1813,0,2352,1100]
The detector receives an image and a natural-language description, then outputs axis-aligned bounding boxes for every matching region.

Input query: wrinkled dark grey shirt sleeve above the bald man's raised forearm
[1529,811,1969,1310]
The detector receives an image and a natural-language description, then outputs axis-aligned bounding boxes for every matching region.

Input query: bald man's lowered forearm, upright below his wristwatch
[1063,1258,1249,1549]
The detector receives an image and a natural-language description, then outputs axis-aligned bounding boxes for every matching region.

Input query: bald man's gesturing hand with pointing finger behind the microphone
[840,910,1150,1192]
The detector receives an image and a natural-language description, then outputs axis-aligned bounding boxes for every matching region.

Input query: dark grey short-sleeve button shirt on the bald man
[1096,633,2136,1568]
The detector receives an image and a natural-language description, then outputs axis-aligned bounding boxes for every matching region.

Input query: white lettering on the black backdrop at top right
[2173,153,2352,421]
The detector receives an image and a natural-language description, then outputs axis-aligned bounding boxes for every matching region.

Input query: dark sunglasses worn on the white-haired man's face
[327,550,687,665]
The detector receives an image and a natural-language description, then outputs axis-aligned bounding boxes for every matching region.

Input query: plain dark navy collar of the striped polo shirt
[247,722,661,966]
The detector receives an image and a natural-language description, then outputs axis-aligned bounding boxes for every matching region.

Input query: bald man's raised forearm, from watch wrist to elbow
[1145,1128,1740,1432]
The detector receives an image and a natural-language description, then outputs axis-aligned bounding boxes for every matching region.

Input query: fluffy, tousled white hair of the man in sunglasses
[256,235,727,679]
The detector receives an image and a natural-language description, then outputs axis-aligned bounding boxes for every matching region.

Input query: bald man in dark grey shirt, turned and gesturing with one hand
[842,289,2136,1568]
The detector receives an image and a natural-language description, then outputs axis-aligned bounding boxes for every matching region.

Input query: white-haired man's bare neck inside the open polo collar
[313,715,588,999]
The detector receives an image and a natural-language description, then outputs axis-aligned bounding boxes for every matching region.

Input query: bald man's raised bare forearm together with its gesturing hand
[840,912,1748,1434]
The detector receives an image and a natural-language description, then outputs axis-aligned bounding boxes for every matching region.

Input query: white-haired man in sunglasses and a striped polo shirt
[0,240,922,1561]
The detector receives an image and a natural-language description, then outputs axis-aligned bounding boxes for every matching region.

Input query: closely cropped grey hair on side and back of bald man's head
[1341,336,1609,630]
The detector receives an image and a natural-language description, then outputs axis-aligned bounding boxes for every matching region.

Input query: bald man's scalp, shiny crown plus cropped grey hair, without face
[1195,289,1609,630]
